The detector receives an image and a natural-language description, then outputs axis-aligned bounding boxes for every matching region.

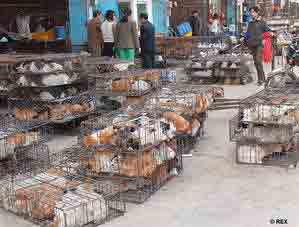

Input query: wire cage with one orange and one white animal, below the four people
[90,69,161,97]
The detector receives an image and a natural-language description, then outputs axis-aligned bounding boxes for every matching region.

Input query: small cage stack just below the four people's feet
[87,58,161,110]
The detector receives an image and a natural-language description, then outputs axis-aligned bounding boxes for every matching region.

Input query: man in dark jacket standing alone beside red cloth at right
[246,6,270,85]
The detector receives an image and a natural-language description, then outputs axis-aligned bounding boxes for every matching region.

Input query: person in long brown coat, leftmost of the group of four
[87,10,103,57]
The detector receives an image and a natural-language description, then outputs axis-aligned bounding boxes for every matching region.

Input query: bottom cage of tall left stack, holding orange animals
[8,84,96,124]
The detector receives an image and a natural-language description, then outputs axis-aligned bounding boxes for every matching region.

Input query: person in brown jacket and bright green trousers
[114,9,139,62]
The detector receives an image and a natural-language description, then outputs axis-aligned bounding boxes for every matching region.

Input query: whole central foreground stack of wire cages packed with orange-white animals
[79,110,183,203]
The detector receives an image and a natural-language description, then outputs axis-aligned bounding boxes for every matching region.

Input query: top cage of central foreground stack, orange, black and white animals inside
[79,110,175,152]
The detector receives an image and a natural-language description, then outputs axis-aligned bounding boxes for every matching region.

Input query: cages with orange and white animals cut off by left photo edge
[0,116,53,178]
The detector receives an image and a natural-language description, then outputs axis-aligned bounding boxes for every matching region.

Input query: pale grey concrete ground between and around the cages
[0,69,299,227]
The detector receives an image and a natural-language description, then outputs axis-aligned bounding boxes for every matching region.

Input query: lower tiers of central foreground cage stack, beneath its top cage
[72,142,183,203]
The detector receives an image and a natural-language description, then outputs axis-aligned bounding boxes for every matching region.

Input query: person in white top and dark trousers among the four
[101,10,116,57]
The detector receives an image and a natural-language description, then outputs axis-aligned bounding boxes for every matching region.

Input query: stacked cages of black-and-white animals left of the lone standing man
[186,36,252,85]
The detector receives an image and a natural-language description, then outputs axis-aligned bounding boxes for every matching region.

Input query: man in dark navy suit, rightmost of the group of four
[140,13,155,69]
